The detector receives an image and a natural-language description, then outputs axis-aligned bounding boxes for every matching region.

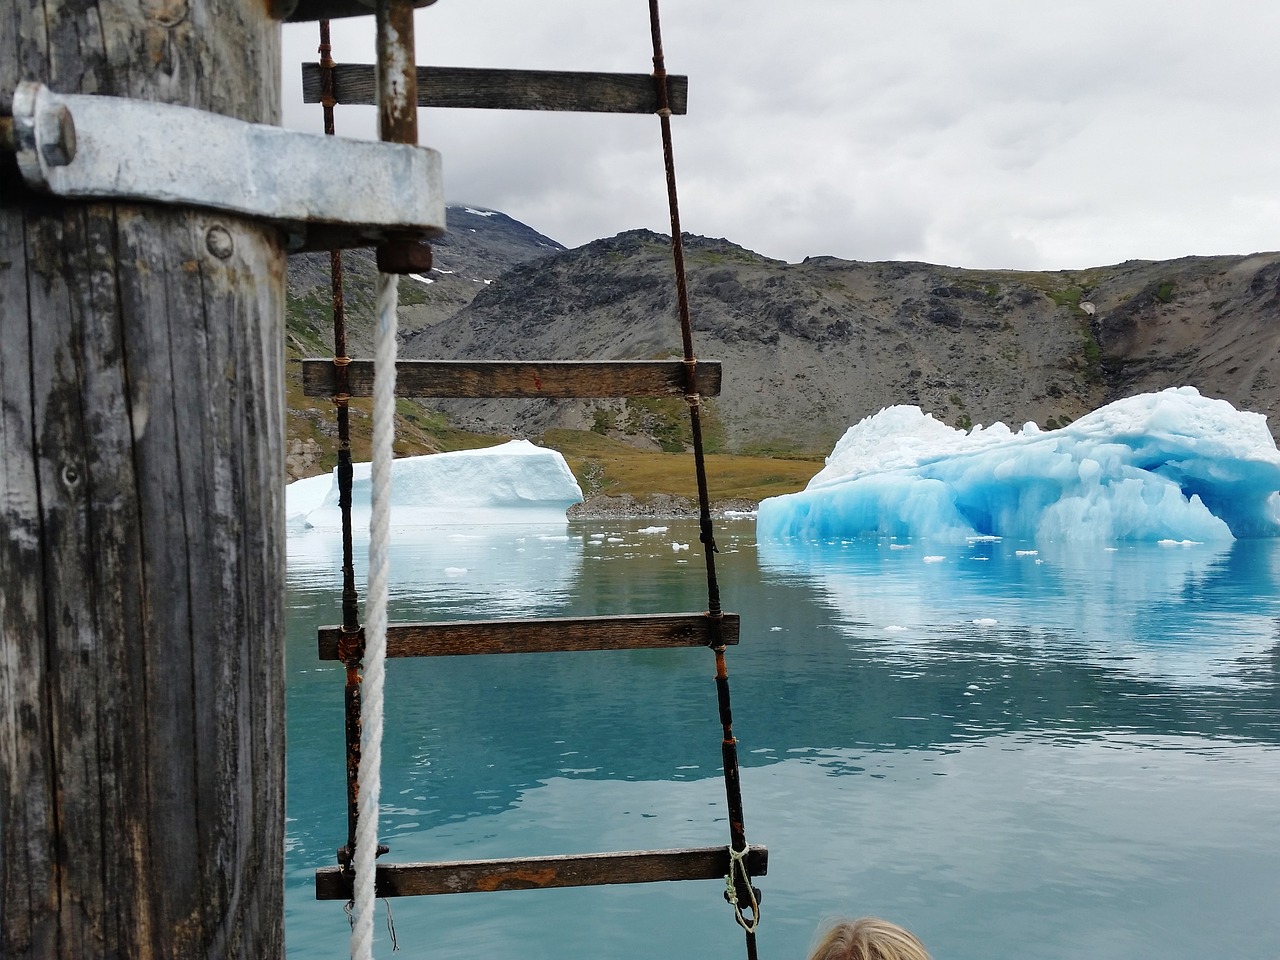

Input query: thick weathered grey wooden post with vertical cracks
[0,0,284,960]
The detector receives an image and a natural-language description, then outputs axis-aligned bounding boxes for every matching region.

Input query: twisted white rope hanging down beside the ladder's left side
[351,274,399,960]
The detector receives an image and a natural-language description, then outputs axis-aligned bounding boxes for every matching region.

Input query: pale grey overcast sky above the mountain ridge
[284,0,1280,269]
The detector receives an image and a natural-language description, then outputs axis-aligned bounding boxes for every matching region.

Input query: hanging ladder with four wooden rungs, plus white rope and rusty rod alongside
[303,0,768,960]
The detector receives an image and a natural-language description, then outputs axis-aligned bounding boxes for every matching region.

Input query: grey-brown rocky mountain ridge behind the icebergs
[291,207,1280,478]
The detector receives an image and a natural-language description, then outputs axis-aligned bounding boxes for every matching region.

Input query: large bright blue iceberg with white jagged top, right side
[756,387,1280,541]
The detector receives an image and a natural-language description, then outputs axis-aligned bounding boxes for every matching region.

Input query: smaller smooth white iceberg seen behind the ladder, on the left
[285,440,582,531]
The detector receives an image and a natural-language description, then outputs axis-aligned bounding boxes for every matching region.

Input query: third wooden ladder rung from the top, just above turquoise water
[319,613,740,660]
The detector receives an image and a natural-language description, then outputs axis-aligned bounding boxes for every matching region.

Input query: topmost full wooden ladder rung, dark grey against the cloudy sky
[302,63,689,114]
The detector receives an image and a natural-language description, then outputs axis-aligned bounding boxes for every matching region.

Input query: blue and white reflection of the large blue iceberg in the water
[759,540,1280,686]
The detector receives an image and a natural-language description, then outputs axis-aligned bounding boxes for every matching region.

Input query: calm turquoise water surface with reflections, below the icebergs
[285,521,1280,960]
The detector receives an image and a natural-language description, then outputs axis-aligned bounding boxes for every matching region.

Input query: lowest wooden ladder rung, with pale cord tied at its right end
[316,846,769,900]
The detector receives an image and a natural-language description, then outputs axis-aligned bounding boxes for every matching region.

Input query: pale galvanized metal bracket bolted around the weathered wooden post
[12,82,444,252]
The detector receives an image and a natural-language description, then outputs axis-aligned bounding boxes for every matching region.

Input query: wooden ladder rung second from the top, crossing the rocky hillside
[302,360,721,399]
